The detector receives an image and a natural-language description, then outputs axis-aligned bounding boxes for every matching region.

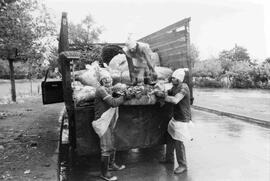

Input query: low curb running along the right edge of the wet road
[192,105,270,128]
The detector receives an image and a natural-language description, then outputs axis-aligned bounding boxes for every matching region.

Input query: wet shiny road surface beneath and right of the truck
[63,110,270,181]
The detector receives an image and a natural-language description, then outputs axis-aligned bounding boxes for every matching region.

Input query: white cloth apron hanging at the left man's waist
[92,107,118,137]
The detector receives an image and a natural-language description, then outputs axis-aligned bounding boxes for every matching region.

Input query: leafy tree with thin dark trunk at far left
[0,0,55,101]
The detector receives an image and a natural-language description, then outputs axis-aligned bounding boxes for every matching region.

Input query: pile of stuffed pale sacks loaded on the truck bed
[72,53,173,105]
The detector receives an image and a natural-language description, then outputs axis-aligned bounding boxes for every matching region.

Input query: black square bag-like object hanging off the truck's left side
[41,70,64,104]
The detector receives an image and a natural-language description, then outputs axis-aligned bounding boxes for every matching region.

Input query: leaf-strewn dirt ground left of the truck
[0,96,63,180]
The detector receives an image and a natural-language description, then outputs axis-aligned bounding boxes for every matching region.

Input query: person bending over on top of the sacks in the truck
[123,38,157,84]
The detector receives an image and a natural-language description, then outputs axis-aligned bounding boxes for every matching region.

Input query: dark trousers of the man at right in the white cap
[166,134,187,167]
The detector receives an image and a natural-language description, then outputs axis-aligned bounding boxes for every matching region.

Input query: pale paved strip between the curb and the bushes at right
[193,88,270,122]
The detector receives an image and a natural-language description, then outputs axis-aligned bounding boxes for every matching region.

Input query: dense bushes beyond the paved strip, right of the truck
[193,46,270,89]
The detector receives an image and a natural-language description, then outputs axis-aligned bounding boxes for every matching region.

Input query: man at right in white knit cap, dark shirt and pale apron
[157,69,191,174]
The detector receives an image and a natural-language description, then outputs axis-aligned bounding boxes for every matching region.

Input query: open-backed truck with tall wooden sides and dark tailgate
[49,12,193,155]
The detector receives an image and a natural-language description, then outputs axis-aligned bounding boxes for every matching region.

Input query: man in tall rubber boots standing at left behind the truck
[95,71,125,181]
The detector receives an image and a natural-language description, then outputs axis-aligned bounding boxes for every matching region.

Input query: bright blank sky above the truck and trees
[43,0,270,61]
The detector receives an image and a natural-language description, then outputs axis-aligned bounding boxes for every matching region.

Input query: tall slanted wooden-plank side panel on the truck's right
[139,18,191,70]
